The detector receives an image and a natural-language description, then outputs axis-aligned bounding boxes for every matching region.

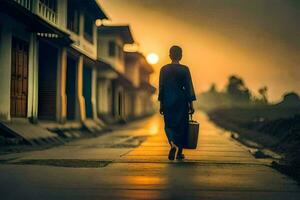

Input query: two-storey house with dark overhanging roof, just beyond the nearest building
[97,25,134,123]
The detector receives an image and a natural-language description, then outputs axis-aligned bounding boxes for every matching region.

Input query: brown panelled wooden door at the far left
[10,38,29,117]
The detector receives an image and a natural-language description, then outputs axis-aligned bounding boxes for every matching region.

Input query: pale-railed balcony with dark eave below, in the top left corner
[5,0,73,45]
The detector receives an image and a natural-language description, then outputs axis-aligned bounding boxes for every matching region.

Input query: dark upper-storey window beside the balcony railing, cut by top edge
[67,1,79,34]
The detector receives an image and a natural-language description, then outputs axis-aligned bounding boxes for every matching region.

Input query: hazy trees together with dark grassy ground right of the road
[197,76,300,177]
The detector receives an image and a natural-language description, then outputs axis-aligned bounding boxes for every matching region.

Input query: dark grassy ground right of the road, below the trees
[208,106,300,180]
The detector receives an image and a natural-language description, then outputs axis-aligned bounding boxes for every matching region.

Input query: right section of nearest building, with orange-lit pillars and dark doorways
[62,0,107,131]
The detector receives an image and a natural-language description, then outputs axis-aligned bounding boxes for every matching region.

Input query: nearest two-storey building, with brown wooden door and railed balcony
[0,0,107,142]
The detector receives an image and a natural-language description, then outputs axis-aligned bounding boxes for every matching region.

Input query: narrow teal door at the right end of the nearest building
[83,67,93,118]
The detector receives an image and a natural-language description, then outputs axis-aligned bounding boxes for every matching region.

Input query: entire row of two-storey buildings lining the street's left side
[0,0,154,142]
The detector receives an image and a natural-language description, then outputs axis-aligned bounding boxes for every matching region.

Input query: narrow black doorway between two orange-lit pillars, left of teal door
[66,57,76,120]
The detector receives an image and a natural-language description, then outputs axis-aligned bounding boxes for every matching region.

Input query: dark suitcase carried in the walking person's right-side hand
[184,115,200,149]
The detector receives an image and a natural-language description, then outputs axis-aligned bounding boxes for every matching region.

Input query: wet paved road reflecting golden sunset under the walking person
[0,113,300,200]
